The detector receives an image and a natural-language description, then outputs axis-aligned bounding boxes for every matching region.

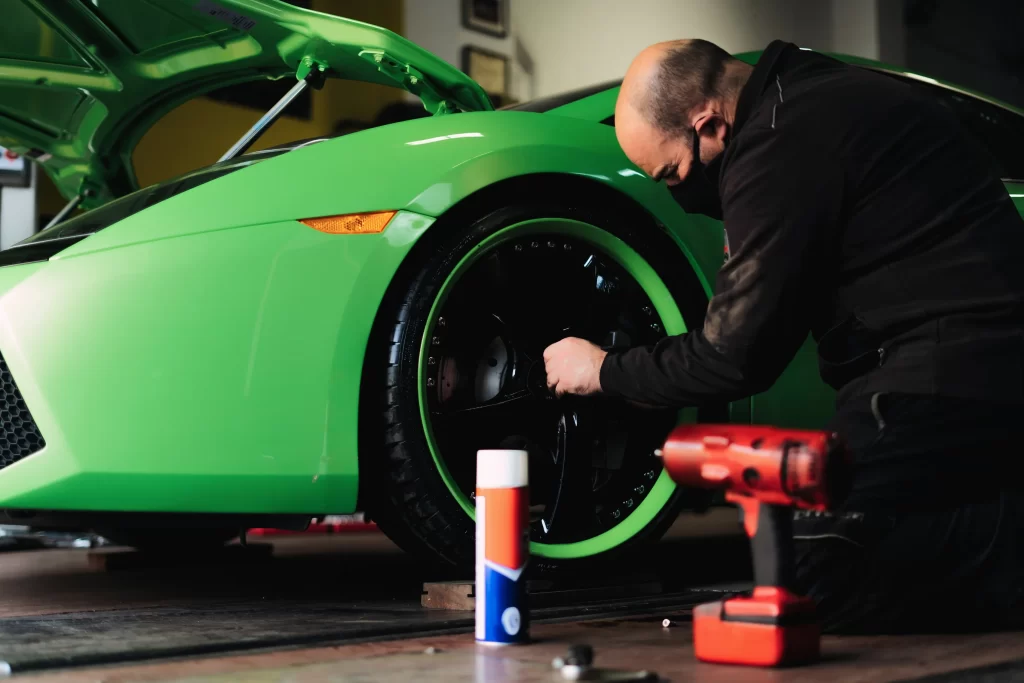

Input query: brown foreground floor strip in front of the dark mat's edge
[14,606,1024,683]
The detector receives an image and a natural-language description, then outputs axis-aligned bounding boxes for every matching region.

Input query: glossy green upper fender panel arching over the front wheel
[56,112,724,287]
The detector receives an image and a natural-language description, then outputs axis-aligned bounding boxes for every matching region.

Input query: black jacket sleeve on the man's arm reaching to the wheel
[600,126,844,408]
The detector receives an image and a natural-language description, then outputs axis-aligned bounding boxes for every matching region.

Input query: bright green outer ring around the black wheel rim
[418,218,696,559]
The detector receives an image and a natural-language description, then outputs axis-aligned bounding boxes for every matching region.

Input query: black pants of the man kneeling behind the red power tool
[794,394,1024,633]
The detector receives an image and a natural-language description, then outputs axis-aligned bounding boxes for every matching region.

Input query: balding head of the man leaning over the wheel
[615,39,751,183]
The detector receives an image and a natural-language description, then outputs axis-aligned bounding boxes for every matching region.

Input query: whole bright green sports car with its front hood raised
[0,0,1024,568]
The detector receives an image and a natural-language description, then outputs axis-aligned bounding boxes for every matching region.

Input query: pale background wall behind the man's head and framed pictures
[406,0,891,99]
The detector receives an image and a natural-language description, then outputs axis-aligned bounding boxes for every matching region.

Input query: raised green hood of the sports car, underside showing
[0,0,493,208]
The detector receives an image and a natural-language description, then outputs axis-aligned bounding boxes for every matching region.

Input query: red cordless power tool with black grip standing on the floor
[662,425,850,667]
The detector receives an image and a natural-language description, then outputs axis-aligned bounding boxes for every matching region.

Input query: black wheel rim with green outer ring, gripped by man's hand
[419,218,696,559]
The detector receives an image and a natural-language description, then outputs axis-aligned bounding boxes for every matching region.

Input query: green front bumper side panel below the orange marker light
[0,213,431,513]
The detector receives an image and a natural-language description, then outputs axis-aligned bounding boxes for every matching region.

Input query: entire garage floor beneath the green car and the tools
[0,510,1024,682]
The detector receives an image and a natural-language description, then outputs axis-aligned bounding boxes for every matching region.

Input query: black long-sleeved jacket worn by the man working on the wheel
[600,41,1024,407]
